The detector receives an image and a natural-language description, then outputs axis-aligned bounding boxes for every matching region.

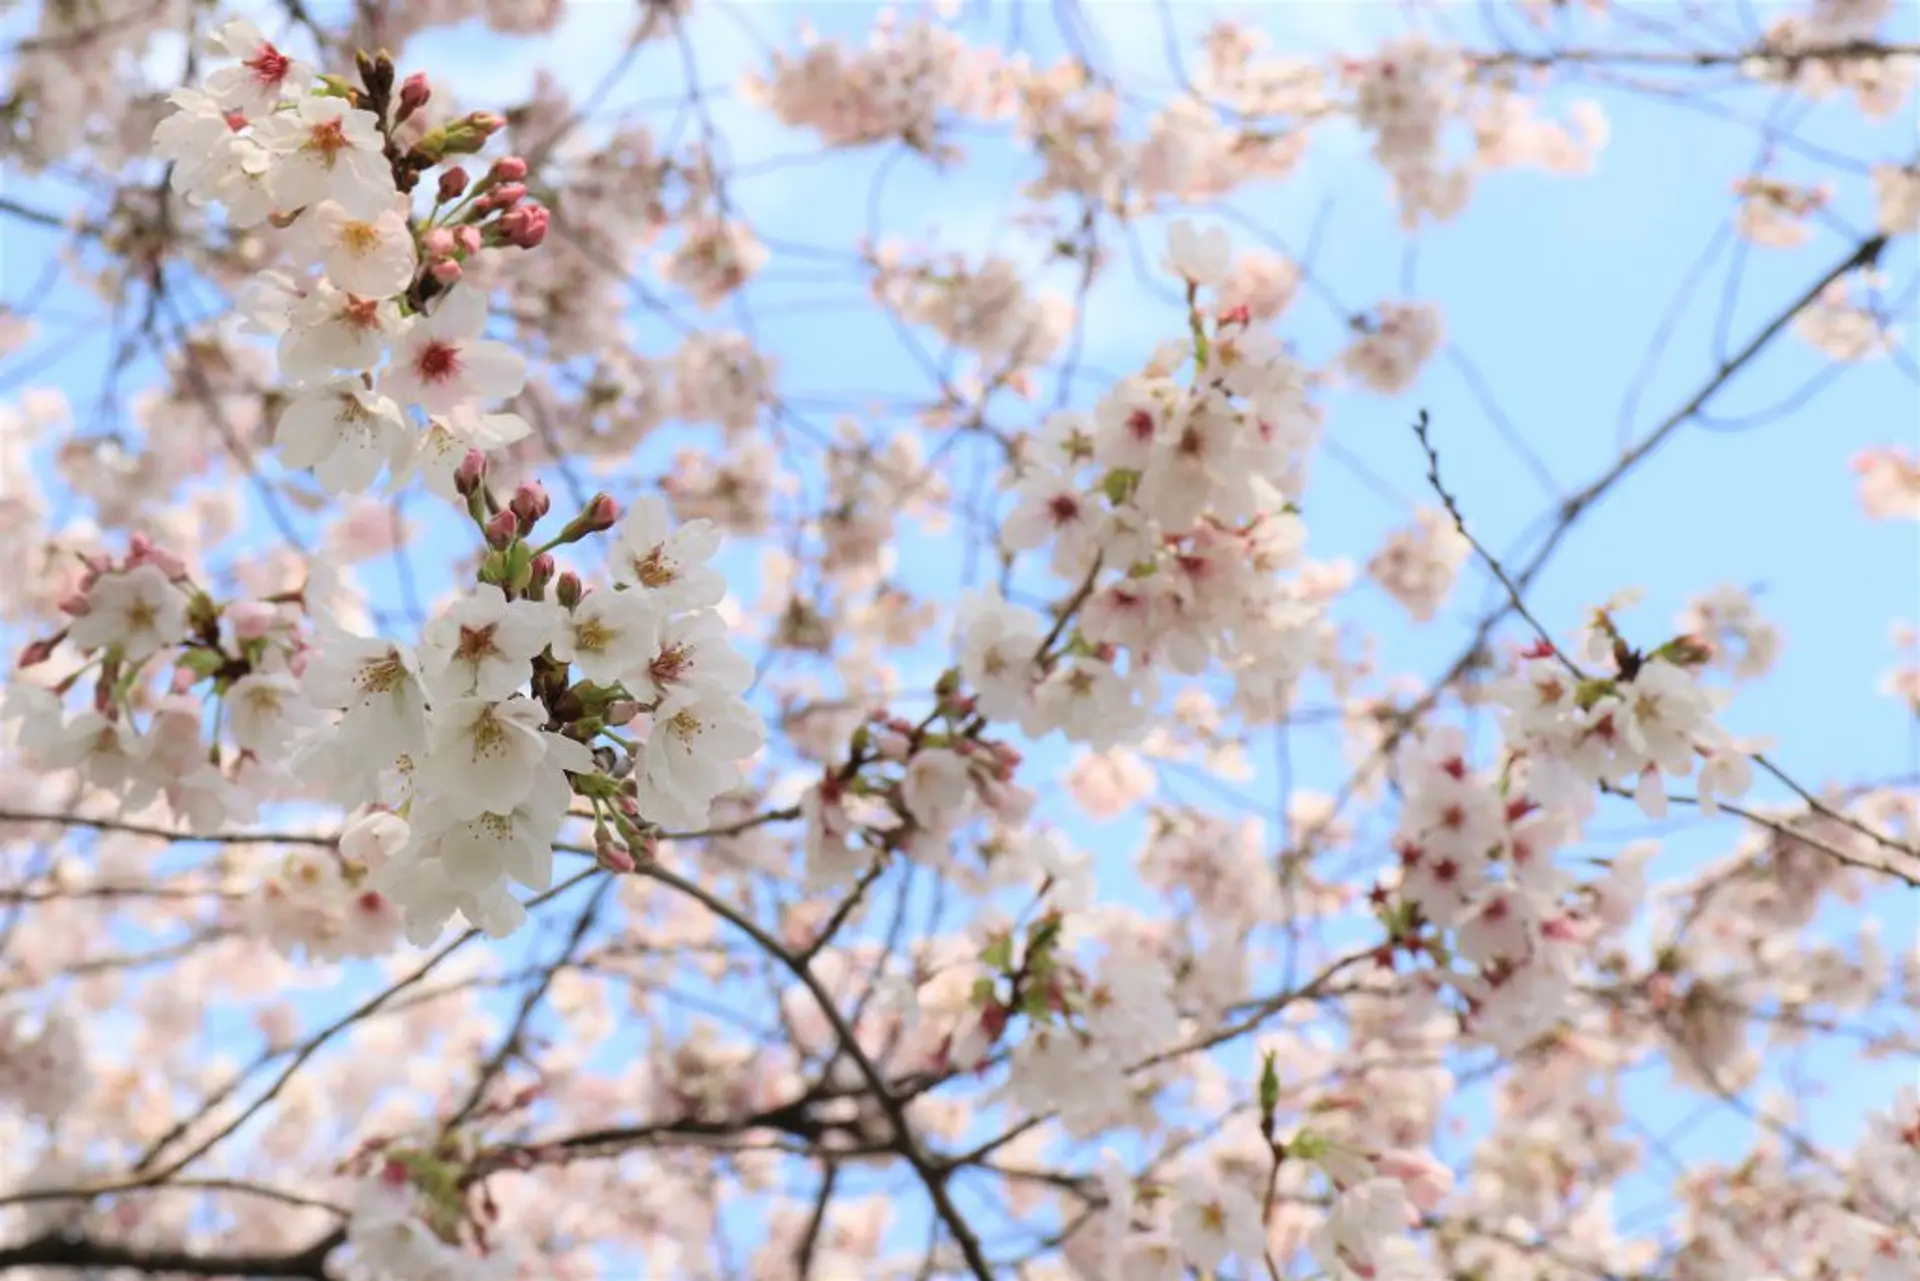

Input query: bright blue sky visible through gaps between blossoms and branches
[0,2,1920,1275]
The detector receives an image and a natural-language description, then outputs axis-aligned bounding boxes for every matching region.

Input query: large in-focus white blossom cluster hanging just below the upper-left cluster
[296,495,762,943]
